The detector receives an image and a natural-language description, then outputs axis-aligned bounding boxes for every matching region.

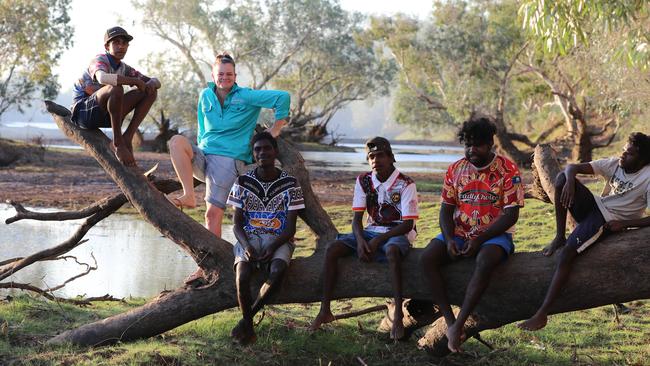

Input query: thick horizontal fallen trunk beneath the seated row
[52,228,650,347]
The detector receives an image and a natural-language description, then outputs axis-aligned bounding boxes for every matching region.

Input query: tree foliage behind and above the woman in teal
[134,0,393,139]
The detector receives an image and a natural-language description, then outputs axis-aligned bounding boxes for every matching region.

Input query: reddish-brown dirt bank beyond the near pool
[0,145,440,209]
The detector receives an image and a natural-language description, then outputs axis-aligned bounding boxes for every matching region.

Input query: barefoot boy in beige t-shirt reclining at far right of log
[519,132,650,330]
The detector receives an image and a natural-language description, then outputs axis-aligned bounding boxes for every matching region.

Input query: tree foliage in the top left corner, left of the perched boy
[0,0,73,116]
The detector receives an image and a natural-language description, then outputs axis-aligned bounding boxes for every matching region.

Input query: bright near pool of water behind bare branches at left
[0,204,234,297]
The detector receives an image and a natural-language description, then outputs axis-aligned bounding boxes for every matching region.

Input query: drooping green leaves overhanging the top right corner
[519,0,650,69]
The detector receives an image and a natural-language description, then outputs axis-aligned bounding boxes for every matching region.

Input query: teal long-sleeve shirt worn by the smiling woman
[196,82,291,164]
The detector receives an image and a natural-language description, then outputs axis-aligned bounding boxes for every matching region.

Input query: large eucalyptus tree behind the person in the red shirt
[367,1,530,164]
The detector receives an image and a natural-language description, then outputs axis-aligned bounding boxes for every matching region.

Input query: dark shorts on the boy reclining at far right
[566,179,607,253]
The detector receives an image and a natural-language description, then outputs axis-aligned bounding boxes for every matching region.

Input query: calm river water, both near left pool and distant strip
[0,144,463,297]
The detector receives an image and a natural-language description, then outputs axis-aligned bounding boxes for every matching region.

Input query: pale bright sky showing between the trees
[10,0,432,139]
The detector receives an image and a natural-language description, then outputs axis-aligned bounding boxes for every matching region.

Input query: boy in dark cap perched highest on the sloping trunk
[71,27,160,166]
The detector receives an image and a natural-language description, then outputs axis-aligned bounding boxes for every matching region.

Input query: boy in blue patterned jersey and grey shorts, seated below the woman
[228,132,305,344]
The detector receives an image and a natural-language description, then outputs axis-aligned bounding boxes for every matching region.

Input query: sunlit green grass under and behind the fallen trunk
[0,184,650,365]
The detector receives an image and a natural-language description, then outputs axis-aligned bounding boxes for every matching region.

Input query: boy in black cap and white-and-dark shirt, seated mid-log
[310,137,418,340]
